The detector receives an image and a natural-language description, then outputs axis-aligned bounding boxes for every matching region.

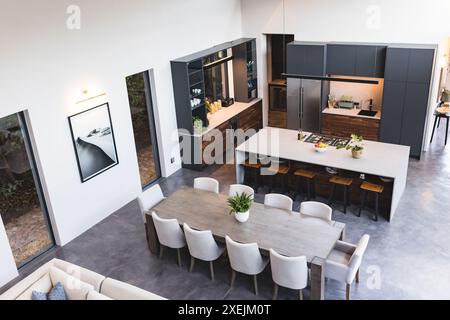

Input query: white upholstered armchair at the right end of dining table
[325,234,370,300]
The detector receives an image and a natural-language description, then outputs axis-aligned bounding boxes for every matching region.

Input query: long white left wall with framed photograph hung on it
[0,0,241,286]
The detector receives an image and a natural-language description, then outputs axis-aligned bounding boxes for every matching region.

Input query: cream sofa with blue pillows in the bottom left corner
[0,259,166,300]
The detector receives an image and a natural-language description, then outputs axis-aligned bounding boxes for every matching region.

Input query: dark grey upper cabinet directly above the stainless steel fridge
[286,41,326,76]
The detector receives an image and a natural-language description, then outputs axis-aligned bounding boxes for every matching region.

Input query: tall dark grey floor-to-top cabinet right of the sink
[380,46,436,158]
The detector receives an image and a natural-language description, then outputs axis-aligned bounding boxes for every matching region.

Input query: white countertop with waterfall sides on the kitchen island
[235,127,409,221]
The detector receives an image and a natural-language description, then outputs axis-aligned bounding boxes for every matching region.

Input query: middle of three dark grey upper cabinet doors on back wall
[327,44,356,76]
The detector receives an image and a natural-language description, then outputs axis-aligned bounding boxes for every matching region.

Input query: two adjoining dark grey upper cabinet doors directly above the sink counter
[326,44,386,78]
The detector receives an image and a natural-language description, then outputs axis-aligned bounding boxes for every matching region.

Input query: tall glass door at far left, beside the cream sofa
[0,113,54,268]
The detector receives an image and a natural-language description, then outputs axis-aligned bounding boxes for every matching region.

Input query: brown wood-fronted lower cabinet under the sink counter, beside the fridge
[322,113,380,141]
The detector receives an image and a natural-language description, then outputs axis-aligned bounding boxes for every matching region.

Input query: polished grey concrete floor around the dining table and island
[3,130,450,299]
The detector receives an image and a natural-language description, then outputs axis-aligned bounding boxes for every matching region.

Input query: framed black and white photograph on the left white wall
[69,103,119,182]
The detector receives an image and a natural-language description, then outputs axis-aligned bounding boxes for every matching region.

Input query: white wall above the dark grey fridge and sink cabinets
[242,0,450,147]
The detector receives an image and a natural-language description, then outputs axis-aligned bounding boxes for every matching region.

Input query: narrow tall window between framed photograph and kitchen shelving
[126,71,161,188]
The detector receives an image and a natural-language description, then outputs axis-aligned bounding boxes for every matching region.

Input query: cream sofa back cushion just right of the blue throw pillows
[50,267,94,300]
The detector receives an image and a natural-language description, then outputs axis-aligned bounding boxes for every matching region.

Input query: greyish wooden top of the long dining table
[152,187,345,262]
